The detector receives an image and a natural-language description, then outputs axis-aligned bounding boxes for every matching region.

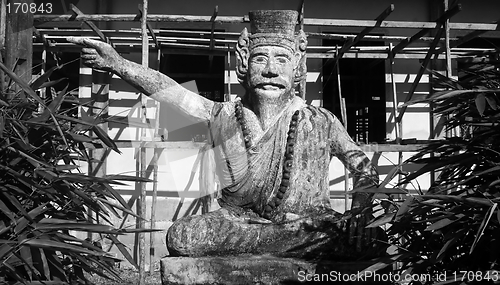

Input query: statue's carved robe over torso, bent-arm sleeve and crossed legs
[167,97,378,259]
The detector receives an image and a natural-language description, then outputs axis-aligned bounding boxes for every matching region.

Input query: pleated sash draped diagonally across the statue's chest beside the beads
[218,96,305,215]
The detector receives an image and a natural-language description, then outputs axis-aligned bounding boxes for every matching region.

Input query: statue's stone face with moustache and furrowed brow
[247,46,295,99]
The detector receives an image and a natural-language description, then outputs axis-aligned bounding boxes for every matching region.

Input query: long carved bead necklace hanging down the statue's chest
[235,101,300,219]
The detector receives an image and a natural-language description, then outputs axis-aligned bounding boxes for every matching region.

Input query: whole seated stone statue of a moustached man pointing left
[69,11,384,260]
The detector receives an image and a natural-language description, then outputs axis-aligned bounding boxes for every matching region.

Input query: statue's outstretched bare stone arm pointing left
[68,37,214,122]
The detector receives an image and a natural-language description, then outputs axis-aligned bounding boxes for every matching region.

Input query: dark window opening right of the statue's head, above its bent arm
[322,39,386,143]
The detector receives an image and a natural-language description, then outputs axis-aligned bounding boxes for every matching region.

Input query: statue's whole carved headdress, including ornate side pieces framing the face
[236,10,307,86]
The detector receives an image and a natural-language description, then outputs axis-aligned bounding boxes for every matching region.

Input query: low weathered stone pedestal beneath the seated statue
[161,255,391,285]
